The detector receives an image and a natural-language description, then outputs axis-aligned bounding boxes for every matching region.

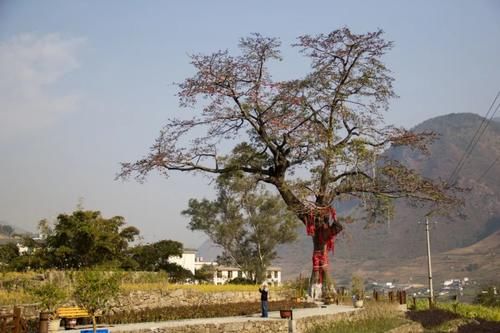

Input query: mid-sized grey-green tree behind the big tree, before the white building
[182,175,297,283]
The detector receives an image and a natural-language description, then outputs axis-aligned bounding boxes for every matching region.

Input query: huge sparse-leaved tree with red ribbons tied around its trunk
[120,28,458,296]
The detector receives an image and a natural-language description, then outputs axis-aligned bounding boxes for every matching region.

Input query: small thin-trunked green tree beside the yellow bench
[74,271,120,333]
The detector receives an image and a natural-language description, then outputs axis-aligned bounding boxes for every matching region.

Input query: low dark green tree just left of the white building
[126,240,182,271]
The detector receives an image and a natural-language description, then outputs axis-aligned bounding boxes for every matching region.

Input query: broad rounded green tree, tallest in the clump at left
[45,210,139,268]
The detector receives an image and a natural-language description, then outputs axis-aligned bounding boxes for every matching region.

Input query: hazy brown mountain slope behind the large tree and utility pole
[277,114,500,280]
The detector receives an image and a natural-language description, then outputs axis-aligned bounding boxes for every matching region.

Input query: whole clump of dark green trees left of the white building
[0,207,193,274]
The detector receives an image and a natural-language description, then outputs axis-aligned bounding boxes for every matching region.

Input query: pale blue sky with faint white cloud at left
[0,0,500,247]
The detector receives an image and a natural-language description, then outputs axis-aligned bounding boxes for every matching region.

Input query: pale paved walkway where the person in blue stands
[73,305,358,333]
